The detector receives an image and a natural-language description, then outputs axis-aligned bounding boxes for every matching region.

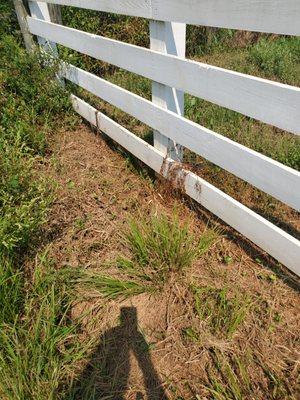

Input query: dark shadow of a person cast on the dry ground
[66,307,168,400]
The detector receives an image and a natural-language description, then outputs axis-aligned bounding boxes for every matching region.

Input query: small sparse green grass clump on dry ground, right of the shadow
[186,286,250,338]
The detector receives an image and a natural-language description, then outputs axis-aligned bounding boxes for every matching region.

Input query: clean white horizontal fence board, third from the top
[62,65,300,211]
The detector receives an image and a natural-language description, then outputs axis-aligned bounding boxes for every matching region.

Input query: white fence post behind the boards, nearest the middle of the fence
[150,21,186,161]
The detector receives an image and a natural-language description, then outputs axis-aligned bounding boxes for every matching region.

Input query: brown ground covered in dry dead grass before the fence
[41,124,300,400]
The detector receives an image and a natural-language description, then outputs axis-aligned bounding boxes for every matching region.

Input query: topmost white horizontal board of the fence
[32,0,300,35]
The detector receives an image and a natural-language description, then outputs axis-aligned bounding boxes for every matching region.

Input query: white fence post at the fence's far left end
[28,1,58,58]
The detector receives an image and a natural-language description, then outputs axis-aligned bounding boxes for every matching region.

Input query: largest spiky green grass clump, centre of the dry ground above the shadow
[118,212,217,286]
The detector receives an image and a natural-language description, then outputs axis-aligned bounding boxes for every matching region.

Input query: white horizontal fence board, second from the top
[28,18,300,134]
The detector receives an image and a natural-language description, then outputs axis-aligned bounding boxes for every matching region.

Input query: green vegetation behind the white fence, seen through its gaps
[61,7,300,175]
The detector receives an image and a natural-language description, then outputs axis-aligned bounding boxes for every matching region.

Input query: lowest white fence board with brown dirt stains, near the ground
[72,95,300,275]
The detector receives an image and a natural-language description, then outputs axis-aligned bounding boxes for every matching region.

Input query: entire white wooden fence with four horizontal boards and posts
[22,0,300,276]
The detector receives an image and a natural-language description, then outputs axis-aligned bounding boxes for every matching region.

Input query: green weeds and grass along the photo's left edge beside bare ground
[0,1,85,400]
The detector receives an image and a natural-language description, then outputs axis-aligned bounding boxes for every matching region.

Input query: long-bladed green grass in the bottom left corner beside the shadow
[0,263,95,400]
